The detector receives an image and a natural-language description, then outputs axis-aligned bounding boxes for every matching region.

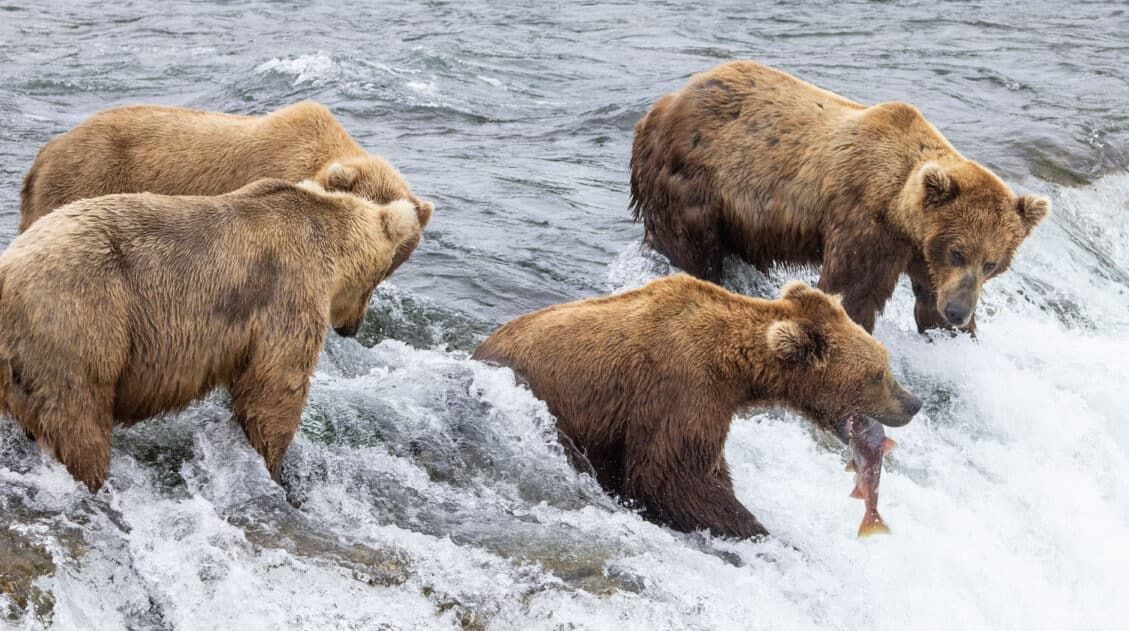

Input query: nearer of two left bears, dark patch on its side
[0,179,430,491]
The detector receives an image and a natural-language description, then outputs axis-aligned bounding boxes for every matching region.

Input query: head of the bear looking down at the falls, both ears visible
[917,163,1050,328]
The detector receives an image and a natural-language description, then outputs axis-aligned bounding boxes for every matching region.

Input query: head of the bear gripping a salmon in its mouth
[764,281,921,427]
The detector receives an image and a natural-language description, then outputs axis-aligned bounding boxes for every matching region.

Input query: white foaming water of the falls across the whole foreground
[0,173,1129,630]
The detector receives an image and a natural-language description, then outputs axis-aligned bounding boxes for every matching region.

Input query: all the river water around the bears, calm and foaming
[0,0,1129,631]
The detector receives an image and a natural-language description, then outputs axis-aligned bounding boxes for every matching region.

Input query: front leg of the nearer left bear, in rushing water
[231,365,309,482]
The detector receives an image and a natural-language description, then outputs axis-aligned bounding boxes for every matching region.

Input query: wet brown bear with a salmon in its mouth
[473,274,921,537]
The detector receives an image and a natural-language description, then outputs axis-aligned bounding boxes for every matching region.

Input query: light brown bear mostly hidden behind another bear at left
[19,100,432,274]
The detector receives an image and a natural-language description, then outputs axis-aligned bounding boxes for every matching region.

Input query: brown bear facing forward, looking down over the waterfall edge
[631,61,1050,332]
